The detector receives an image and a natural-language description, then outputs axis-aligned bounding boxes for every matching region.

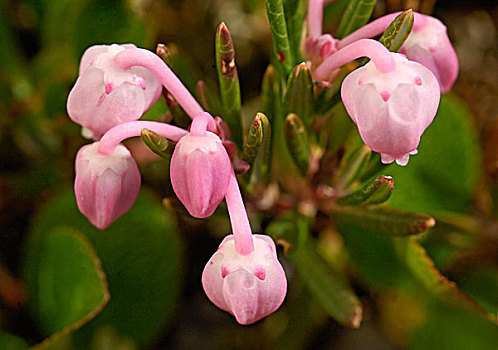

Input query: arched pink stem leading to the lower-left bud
[99,120,188,155]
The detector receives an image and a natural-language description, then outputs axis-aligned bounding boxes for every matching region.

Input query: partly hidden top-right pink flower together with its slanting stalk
[337,12,458,93]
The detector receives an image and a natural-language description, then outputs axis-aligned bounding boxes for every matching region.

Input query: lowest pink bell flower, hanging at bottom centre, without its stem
[202,235,287,325]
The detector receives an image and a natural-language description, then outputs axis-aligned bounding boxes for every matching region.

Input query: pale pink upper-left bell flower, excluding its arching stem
[67,44,162,140]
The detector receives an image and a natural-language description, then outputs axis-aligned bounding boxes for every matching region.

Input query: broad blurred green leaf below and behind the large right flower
[390,95,481,213]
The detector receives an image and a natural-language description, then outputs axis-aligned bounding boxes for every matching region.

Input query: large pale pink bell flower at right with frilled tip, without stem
[341,53,440,165]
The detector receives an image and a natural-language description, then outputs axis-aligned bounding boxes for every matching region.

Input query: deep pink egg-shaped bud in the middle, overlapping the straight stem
[170,131,232,218]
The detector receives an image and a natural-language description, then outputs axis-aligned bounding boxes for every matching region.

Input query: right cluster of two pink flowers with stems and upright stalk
[303,0,458,165]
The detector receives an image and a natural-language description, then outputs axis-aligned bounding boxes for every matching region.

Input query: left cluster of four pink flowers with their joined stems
[67,45,287,324]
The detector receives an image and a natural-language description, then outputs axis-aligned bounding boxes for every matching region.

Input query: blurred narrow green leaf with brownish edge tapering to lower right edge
[395,237,496,322]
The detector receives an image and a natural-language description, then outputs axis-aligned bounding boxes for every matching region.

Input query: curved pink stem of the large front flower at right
[313,39,396,80]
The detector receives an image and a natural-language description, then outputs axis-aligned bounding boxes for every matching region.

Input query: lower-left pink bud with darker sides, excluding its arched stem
[74,142,140,230]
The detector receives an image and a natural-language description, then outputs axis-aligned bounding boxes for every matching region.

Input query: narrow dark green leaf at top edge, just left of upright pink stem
[284,0,305,64]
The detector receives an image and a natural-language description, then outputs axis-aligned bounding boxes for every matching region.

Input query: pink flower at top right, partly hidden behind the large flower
[400,14,458,92]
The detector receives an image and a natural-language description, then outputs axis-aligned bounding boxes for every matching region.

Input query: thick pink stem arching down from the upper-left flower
[114,48,204,118]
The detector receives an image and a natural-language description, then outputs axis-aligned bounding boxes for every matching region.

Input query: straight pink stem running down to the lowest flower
[225,169,254,255]
